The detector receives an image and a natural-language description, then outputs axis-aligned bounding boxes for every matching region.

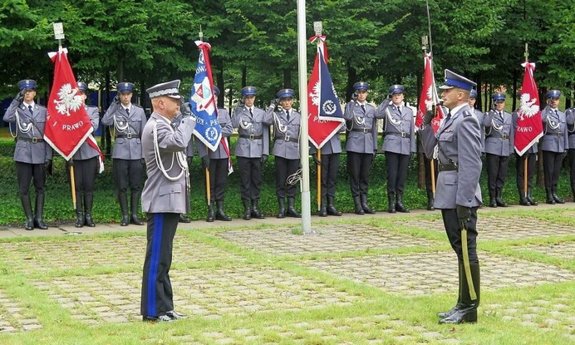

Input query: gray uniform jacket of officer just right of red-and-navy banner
[343,101,382,154]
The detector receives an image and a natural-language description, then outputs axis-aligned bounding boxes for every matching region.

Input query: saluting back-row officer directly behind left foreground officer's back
[102,82,146,226]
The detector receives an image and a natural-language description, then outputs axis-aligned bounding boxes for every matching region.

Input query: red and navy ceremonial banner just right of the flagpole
[307,36,345,149]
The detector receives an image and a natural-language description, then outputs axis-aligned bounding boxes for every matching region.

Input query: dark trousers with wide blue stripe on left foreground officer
[141,213,180,317]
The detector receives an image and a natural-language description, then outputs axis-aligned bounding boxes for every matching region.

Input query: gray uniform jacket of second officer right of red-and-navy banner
[377,100,417,155]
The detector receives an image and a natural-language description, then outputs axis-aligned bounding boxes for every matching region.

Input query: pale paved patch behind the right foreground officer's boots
[301,252,575,295]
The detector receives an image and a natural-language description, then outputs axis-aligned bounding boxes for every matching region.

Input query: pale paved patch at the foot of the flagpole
[217,224,434,255]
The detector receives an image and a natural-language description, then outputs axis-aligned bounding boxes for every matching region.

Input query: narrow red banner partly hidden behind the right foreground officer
[415,54,444,132]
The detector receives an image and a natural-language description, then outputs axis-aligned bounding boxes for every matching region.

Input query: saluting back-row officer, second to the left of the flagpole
[232,86,273,220]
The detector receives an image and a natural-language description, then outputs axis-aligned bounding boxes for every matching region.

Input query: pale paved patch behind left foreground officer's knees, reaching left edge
[0,235,243,273]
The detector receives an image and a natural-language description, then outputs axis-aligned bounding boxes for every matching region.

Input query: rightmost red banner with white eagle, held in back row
[514,62,543,156]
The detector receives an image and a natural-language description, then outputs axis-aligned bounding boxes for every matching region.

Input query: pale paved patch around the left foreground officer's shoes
[34,266,362,323]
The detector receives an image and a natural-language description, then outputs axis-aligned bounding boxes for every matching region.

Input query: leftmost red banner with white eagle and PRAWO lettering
[44,48,103,170]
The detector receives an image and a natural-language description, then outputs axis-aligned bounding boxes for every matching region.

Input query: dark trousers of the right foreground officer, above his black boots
[441,207,479,264]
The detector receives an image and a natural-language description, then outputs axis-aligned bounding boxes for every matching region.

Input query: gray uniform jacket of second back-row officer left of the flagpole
[232,106,273,158]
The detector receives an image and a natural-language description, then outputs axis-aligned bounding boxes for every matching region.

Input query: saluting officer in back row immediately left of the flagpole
[272,89,301,218]
